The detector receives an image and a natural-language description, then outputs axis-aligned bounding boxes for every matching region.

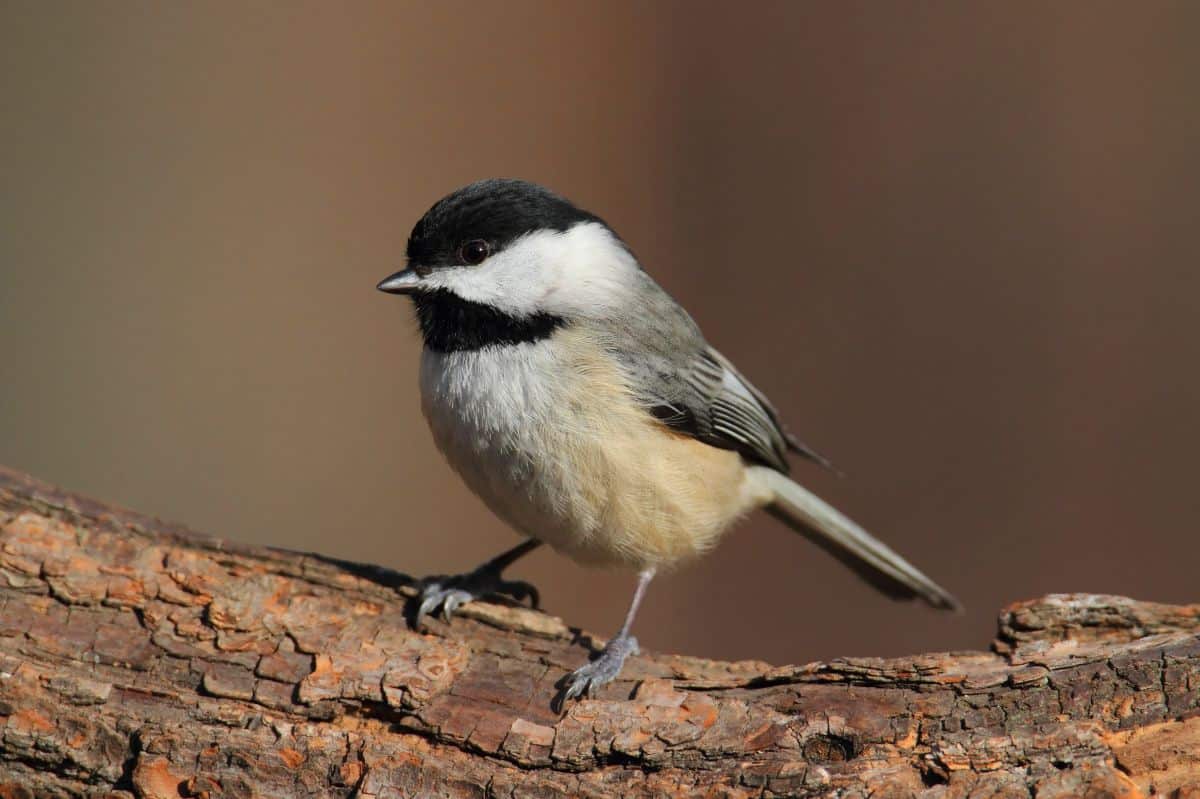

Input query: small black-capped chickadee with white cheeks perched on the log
[378,180,959,699]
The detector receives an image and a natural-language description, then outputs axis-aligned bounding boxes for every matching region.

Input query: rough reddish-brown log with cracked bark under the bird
[0,460,1200,799]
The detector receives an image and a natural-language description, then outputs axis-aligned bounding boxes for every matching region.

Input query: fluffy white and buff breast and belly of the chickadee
[421,331,764,569]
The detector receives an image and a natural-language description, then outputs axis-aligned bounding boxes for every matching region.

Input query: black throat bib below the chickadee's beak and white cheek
[413,289,566,353]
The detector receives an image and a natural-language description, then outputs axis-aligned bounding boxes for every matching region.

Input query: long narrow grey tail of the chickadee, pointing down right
[755,467,962,611]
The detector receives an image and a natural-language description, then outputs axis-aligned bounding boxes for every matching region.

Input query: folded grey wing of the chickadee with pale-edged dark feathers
[608,274,829,474]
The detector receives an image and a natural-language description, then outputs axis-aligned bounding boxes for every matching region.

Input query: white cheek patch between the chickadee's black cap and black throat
[425,222,637,317]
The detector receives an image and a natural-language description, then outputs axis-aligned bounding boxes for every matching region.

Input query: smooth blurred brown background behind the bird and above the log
[0,2,1200,662]
